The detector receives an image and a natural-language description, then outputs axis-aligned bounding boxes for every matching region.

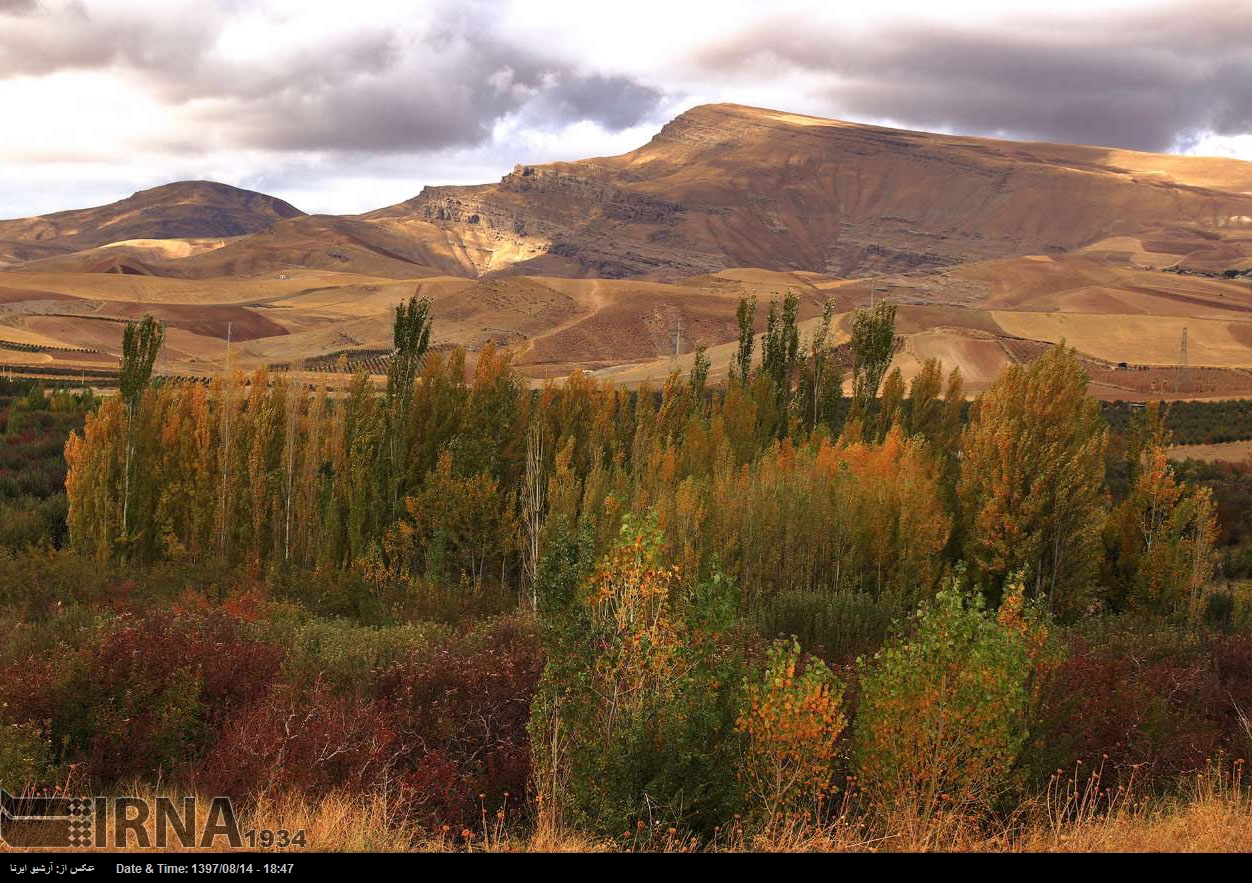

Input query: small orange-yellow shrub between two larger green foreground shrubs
[735,638,848,819]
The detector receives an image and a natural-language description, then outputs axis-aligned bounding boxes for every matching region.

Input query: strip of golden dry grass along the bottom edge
[0,760,1252,853]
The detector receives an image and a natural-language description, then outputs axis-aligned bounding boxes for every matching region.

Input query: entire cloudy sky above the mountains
[0,0,1252,218]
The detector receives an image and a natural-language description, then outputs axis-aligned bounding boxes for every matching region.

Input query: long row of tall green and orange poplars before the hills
[65,294,1216,617]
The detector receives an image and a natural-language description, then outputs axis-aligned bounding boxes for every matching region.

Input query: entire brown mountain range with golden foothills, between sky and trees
[0,105,1252,400]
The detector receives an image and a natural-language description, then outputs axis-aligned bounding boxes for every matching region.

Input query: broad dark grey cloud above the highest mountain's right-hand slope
[697,1,1252,150]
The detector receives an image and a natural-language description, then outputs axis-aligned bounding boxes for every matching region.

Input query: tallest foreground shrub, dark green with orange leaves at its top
[531,517,741,835]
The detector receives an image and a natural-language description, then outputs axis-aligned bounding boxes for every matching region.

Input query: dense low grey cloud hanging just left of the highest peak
[195,33,661,152]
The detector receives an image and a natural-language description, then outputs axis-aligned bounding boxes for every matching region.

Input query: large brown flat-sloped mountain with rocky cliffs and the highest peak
[364,105,1252,278]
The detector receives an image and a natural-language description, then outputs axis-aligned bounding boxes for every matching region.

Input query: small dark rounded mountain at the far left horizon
[0,180,303,261]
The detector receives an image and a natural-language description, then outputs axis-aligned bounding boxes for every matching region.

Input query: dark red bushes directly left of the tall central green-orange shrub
[194,620,543,825]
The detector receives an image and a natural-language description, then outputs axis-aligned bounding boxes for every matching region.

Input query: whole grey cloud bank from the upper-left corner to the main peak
[0,0,661,152]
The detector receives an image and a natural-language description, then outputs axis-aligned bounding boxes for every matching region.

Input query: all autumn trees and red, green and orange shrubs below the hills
[7,296,1252,848]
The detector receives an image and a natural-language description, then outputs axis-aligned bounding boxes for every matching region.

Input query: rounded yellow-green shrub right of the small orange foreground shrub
[854,582,1033,818]
